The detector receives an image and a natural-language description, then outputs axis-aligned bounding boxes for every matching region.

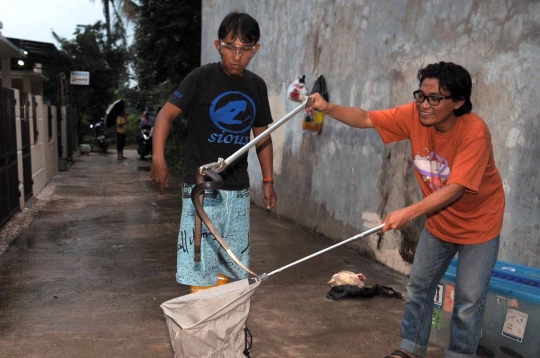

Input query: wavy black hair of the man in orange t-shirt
[418,62,472,117]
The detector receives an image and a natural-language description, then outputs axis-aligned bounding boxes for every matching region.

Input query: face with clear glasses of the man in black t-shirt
[214,34,260,77]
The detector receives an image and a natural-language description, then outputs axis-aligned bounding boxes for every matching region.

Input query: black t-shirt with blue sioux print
[169,62,272,190]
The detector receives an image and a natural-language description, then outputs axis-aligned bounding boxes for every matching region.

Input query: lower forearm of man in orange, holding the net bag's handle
[383,183,465,232]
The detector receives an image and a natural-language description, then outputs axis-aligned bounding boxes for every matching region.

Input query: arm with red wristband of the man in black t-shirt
[252,126,277,209]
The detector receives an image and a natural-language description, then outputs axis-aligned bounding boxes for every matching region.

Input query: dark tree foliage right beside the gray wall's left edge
[128,0,201,111]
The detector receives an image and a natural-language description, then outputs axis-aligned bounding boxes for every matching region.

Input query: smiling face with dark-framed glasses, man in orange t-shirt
[416,78,465,132]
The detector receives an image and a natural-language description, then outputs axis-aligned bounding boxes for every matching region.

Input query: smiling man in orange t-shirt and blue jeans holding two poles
[307,62,505,358]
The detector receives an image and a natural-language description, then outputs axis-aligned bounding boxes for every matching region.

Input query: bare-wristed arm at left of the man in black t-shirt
[150,102,182,195]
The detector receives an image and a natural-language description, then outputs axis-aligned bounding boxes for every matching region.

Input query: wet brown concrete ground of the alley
[0,151,442,358]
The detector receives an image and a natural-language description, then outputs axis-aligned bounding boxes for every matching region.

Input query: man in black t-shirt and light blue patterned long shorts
[150,13,277,292]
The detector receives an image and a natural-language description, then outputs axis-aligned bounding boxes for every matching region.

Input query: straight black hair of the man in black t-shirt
[218,12,261,44]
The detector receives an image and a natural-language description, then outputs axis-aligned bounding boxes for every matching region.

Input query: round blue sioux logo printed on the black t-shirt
[208,91,256,145]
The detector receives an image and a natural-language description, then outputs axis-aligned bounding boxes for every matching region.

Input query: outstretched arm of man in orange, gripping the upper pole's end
[306,93,375,128]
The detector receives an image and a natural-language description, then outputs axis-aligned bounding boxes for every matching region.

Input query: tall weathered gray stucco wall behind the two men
[201,0,540,273]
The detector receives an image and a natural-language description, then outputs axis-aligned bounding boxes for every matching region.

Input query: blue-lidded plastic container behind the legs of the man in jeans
[430,259,540,358]
